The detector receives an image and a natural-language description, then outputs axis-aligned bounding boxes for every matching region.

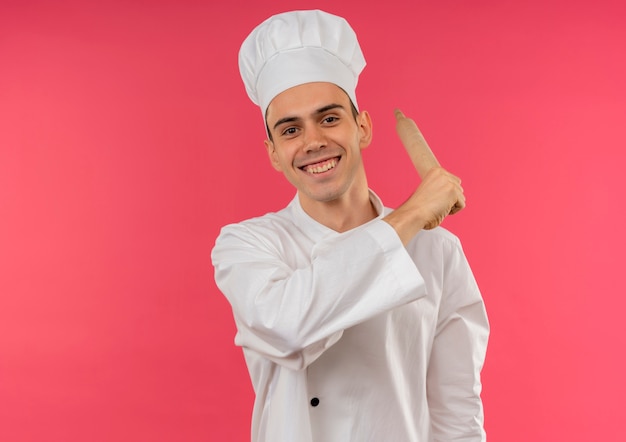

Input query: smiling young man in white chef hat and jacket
[212,11,489,442]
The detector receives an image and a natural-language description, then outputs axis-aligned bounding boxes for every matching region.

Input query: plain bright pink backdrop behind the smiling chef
[0,0,626,442]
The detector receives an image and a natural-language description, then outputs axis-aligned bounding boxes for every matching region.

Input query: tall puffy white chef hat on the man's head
[239,10,365,116]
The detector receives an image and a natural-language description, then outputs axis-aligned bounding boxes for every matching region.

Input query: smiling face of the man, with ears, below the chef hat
[265,83,372,204]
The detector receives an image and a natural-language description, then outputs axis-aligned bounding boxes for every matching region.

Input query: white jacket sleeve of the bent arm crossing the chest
[212,220,425,369]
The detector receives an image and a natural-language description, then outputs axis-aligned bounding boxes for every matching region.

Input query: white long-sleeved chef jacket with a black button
[212,192,489,442]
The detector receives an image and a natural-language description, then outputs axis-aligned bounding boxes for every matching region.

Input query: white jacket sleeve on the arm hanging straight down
[427,238,489,442]
